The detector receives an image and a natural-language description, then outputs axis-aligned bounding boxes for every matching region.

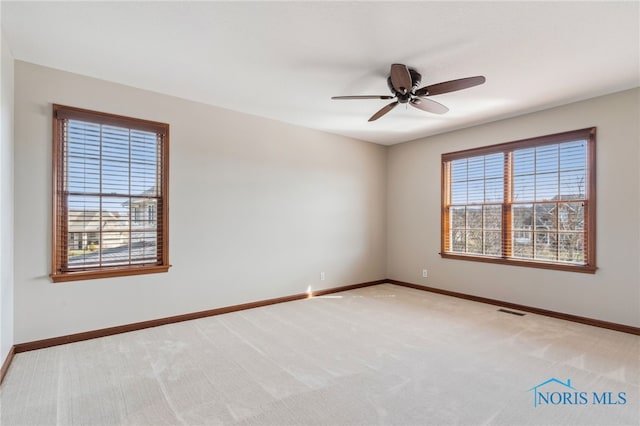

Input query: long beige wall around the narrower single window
[15,61,386,343]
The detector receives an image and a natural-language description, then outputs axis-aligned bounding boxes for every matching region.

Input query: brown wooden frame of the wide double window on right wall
[440,127,597,274]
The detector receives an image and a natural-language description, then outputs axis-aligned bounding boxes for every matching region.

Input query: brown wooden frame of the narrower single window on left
[50,104,170,282]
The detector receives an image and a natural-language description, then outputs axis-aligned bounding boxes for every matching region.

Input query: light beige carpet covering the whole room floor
[0,284,640,425]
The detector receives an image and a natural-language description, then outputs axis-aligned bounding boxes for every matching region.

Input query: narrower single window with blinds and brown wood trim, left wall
[51,105,169,282]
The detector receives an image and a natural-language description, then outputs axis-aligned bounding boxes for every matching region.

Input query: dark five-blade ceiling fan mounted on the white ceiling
[331,64,486,121]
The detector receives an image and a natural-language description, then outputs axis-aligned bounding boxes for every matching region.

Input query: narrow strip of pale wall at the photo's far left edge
[0,32,14,365]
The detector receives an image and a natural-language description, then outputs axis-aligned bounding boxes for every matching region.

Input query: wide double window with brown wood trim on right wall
[441,128,596,273]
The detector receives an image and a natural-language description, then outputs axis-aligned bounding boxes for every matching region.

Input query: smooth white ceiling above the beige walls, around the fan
[1,1,640,145]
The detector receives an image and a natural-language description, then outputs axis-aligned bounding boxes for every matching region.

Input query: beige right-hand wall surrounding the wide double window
[387,89,640,327]
